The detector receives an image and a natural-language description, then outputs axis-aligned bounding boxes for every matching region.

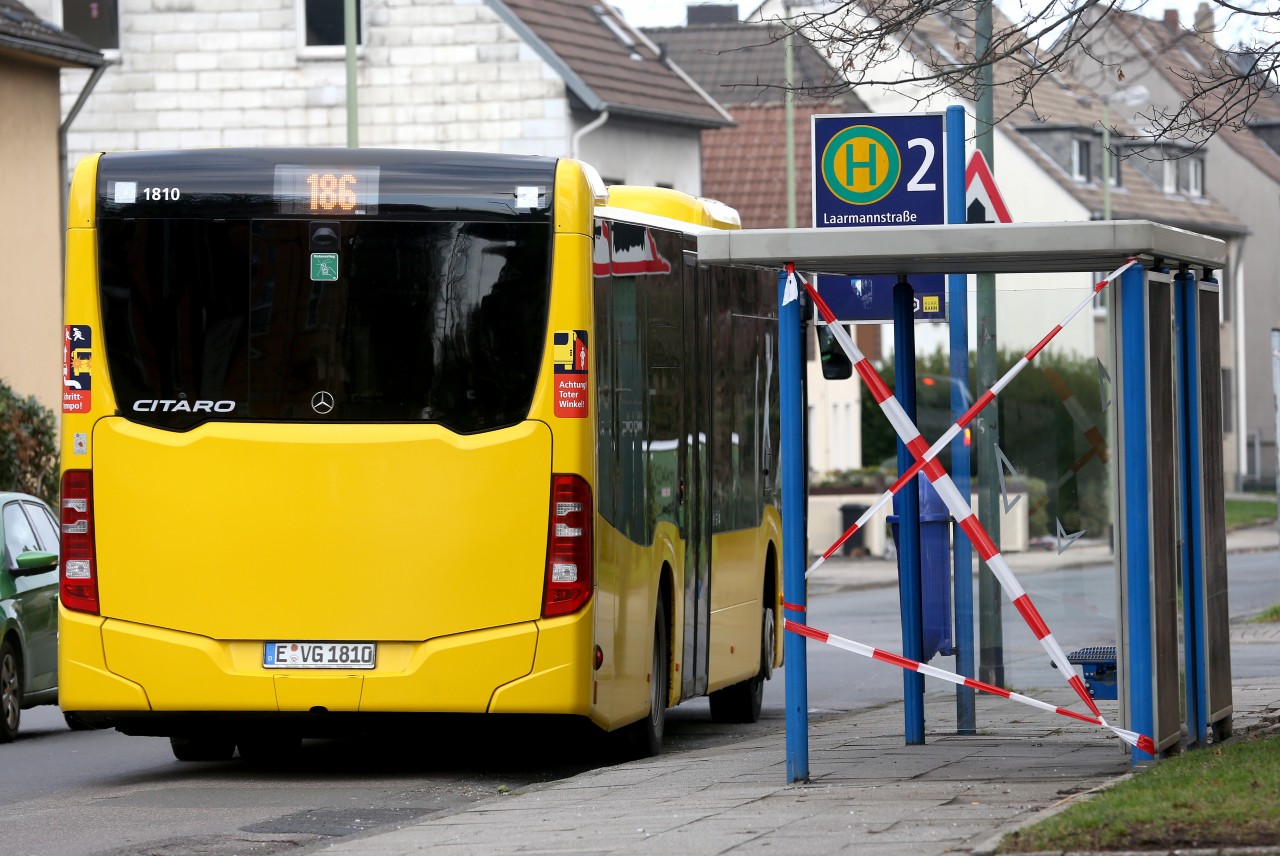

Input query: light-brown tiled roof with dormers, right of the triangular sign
[914,13,1248,234]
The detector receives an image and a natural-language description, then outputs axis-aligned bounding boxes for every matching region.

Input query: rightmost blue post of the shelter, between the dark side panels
[1174,270,1208,747]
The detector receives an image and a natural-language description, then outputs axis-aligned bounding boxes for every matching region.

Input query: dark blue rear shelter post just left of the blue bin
[893,279,924,746]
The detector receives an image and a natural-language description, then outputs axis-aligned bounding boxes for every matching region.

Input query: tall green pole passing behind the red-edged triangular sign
[974,0,1005,687]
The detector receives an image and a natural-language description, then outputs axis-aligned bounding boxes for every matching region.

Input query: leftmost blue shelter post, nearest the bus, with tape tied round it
[778,271,809,783]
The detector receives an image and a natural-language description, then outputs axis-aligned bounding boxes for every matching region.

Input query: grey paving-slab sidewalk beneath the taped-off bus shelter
[314,530,1280,856]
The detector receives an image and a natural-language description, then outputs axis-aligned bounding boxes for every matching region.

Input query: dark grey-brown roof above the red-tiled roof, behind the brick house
[645,23,860,106]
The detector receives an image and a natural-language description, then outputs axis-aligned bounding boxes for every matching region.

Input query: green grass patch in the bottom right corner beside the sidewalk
[997,737,1280,853]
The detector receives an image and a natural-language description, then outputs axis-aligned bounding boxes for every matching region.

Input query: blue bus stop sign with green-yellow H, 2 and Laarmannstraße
[813,113,946,228]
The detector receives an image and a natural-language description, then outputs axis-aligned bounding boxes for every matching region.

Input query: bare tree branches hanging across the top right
[752,0,1280,150]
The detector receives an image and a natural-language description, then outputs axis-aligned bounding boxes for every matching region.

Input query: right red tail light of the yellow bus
[543,473,595,618]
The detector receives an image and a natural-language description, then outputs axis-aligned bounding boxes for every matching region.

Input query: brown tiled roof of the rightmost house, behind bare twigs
[1106,9,1280,182]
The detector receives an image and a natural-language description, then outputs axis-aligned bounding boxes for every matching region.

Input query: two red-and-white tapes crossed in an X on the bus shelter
[783,258,1137,745]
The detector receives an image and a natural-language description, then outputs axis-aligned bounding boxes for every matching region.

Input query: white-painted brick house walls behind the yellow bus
[42,0,699,192]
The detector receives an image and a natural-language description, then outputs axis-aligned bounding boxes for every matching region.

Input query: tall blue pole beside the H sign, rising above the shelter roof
[947,105,978,734]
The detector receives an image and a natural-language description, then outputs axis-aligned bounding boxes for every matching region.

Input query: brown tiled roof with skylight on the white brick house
[488,0,732,128]
